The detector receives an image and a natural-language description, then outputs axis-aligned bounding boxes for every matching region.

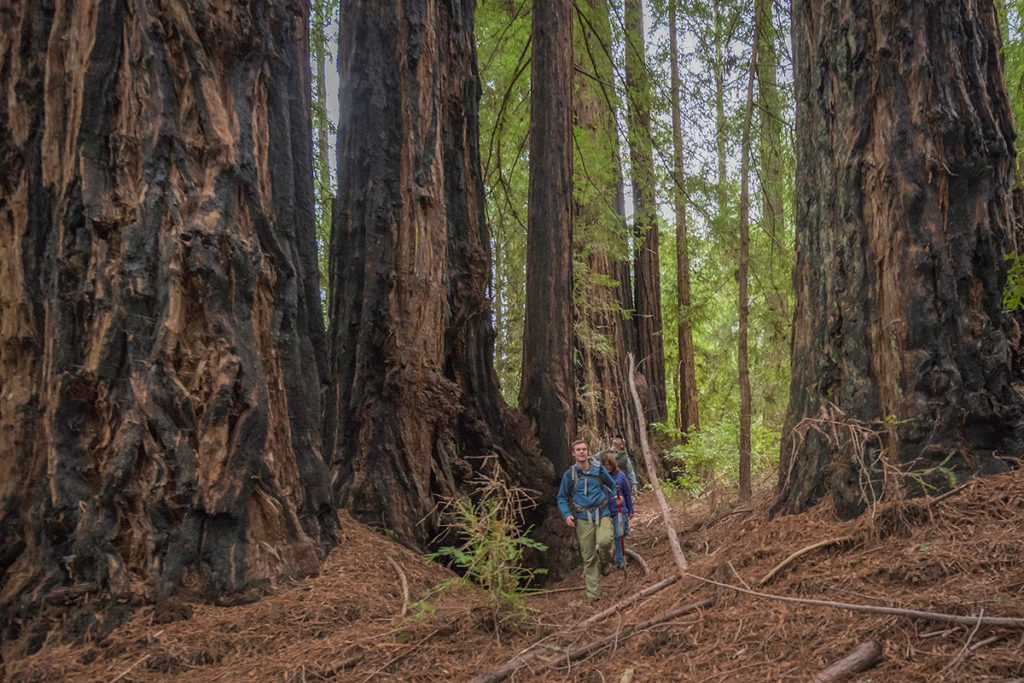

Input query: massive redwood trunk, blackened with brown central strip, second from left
[325,0,554,548]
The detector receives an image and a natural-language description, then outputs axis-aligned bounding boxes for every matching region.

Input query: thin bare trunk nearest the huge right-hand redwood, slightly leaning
[736,0,762,501]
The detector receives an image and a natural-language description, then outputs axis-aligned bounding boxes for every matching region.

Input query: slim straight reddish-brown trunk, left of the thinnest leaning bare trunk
[669,0,700,433]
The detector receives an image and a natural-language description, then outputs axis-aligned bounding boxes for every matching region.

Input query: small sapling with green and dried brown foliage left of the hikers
[427,473,548,631]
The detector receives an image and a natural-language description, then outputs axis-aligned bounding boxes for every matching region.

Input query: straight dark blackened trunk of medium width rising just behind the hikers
[519,0,575,473]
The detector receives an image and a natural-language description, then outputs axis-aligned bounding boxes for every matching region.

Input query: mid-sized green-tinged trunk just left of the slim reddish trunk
[626,0,669,423]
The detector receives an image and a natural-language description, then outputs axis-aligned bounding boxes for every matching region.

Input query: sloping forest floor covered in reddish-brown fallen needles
[5,470,1024,683]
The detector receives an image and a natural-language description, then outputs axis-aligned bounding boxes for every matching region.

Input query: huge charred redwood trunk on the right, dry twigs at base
[776,0,1024,515]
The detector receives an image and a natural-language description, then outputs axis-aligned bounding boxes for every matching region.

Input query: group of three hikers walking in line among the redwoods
[558,436,637,600]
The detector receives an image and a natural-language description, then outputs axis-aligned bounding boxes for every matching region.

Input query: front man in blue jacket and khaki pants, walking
[558,439,618,600]
